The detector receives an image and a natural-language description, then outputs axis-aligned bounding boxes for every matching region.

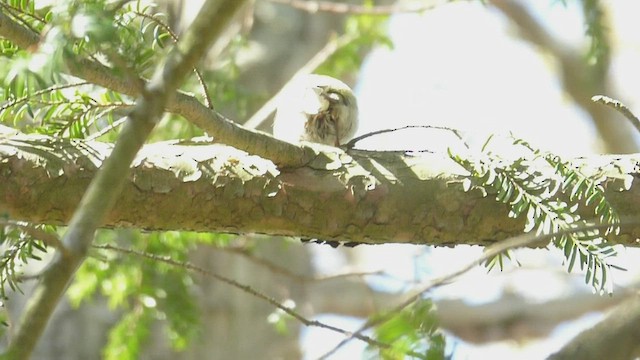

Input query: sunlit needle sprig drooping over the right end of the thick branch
[449,139,620,293]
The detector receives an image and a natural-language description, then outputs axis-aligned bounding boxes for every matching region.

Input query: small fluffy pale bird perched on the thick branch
[273,74,358,147]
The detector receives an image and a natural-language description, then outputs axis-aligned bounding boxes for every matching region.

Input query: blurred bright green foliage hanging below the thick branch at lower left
[67,230,229,359]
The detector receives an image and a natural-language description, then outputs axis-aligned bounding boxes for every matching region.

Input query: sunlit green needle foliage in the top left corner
[0,0,174,138]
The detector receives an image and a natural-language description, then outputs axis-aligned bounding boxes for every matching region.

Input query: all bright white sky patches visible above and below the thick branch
[303,0,640,359]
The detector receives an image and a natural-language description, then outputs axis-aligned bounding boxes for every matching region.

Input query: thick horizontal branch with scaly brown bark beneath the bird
[0,127,640,245]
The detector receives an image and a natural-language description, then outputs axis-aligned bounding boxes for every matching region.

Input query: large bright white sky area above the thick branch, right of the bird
[356,1,593,153]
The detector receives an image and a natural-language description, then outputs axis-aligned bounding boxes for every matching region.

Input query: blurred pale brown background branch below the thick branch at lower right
[305,278,631,344]
